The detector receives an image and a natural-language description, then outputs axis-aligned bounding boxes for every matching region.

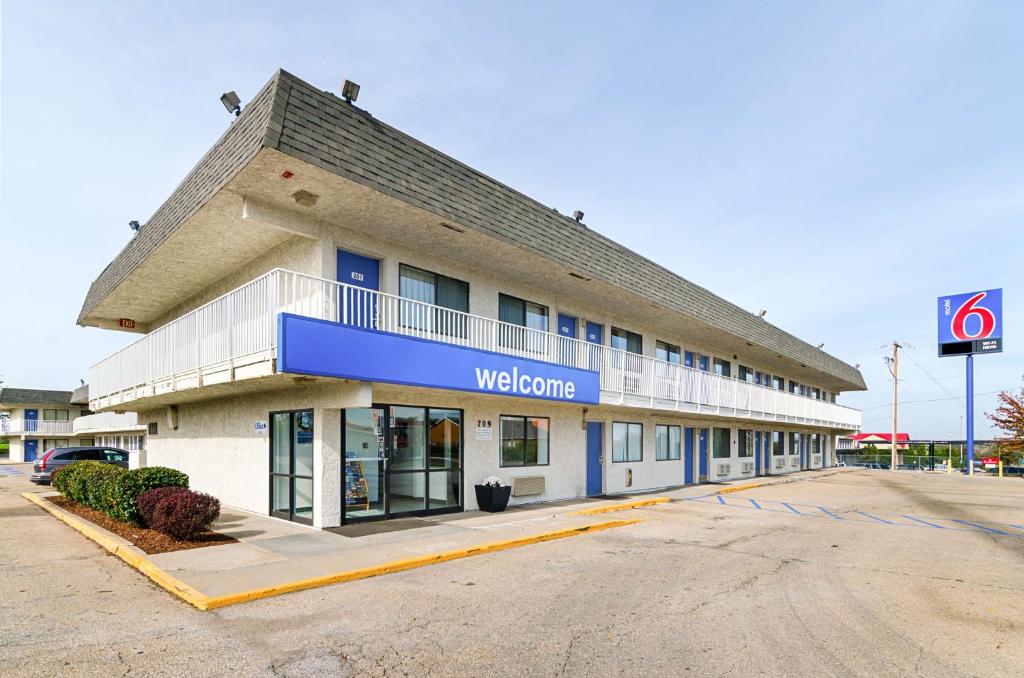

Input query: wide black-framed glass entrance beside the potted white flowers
[343,406,462,522]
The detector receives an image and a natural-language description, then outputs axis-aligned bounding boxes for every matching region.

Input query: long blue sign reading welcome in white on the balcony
[278,313,601,405]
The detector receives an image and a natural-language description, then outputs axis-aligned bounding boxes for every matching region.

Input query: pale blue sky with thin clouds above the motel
[0,0,1024,437]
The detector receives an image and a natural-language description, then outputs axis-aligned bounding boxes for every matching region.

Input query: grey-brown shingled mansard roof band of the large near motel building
[79,71,865,389]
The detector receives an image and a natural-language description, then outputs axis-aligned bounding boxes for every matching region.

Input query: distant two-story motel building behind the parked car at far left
[0,385,145,466]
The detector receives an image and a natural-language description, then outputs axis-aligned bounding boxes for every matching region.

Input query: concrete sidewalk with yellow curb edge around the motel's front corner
[23,492,668,609]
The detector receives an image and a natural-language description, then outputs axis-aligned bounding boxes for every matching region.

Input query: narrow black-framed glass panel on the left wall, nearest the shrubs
[270,410,313,524]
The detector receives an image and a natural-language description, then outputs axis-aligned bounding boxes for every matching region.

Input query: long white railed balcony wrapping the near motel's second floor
[89,269,861,430]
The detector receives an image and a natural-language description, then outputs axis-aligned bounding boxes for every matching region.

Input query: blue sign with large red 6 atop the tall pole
[939,289,1002,357]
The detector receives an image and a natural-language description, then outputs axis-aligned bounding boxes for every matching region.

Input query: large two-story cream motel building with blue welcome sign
[79,72,864,527]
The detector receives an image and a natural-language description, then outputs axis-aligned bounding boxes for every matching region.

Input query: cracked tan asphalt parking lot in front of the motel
[0,471,1024,676]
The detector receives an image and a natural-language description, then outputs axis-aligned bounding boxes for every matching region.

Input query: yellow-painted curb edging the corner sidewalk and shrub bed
[22,493,638,610]
